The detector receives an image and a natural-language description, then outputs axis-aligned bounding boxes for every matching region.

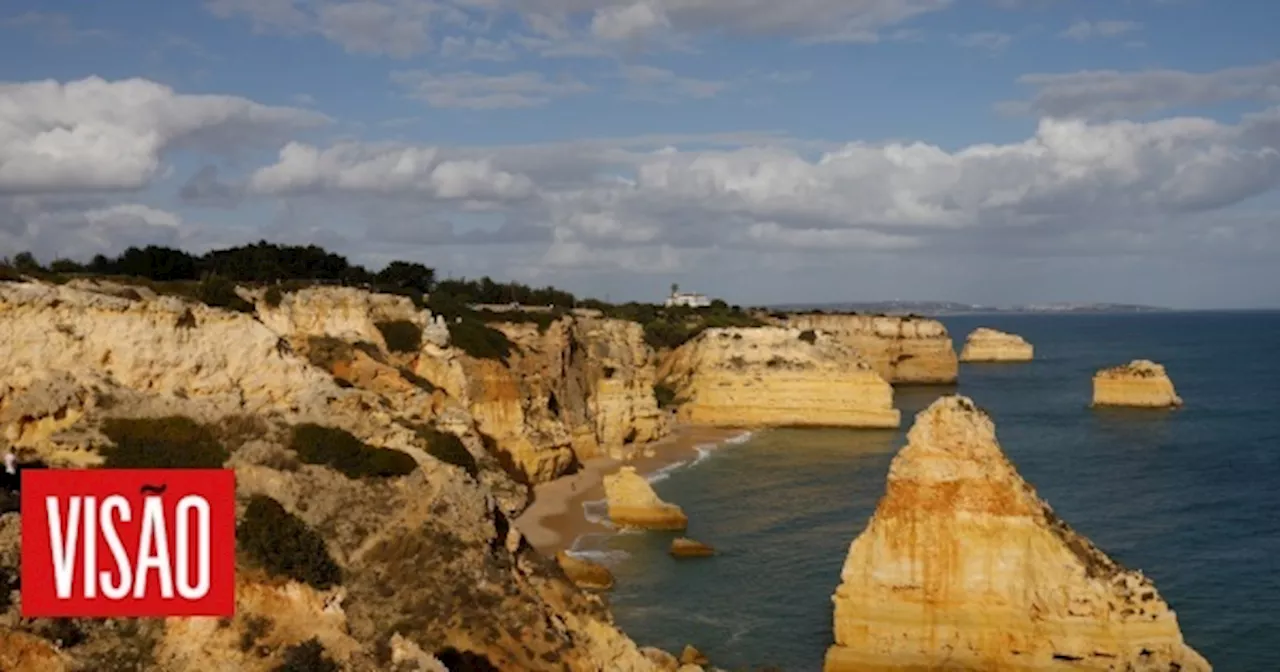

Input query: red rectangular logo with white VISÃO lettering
[22,468,236,618]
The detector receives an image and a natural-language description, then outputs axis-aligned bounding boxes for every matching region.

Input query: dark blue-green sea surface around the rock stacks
[577,312,1280,672]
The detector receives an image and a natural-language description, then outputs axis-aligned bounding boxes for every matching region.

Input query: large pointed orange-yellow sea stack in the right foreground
[824,396,1211,672]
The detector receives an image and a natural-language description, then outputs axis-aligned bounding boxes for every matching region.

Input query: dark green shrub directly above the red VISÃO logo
[102,416,229,468]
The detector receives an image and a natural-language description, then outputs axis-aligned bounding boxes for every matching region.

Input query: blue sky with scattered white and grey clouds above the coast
[0,0,1280,308]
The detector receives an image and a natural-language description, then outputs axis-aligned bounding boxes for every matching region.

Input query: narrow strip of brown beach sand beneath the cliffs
[515,425,744,556]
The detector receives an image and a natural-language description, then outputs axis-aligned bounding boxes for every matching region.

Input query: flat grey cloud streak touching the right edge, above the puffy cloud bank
[998,61,1280,118]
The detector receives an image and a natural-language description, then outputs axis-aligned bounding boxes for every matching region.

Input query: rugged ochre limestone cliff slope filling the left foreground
[0,282,654,672]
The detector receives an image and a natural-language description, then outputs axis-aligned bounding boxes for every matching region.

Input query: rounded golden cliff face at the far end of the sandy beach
[659,326,900,428]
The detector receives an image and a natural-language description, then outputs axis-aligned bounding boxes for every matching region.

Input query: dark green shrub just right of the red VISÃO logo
[236,495,342,590]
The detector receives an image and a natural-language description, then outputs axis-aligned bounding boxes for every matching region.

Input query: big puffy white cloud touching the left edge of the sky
[0,77,325,195]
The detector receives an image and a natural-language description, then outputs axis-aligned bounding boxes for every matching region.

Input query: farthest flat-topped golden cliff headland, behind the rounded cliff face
[780,314,959,384]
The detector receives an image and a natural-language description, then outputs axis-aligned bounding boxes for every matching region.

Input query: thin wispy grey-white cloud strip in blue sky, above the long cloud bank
[392,70,590,110]
